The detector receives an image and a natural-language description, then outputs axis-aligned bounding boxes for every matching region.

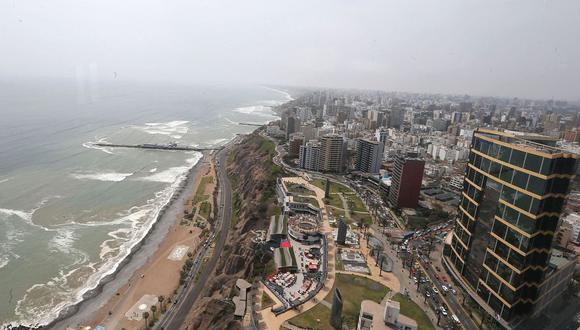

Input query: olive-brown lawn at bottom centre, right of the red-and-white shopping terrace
[290,274,389,329]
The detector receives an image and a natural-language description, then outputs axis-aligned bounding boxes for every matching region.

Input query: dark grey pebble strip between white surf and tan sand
[42,151,210,329]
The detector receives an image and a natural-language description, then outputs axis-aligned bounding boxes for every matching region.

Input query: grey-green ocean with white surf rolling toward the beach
[0,81,291,325]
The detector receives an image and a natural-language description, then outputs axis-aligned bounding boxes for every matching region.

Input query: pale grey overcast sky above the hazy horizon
[0,0,580,100]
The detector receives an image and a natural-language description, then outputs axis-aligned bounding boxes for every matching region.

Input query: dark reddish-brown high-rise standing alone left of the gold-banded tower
[389,153,425,208]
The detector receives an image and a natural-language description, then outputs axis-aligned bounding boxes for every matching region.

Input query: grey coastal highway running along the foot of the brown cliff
[157,147,232,330]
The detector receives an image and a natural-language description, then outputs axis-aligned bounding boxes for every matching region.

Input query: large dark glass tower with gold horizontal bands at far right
[444,128,577,329]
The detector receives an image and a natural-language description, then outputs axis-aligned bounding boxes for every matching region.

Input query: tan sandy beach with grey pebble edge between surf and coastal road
[49,153,215,329]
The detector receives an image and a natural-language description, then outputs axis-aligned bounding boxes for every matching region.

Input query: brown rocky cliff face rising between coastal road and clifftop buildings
[190,133,281,329]
